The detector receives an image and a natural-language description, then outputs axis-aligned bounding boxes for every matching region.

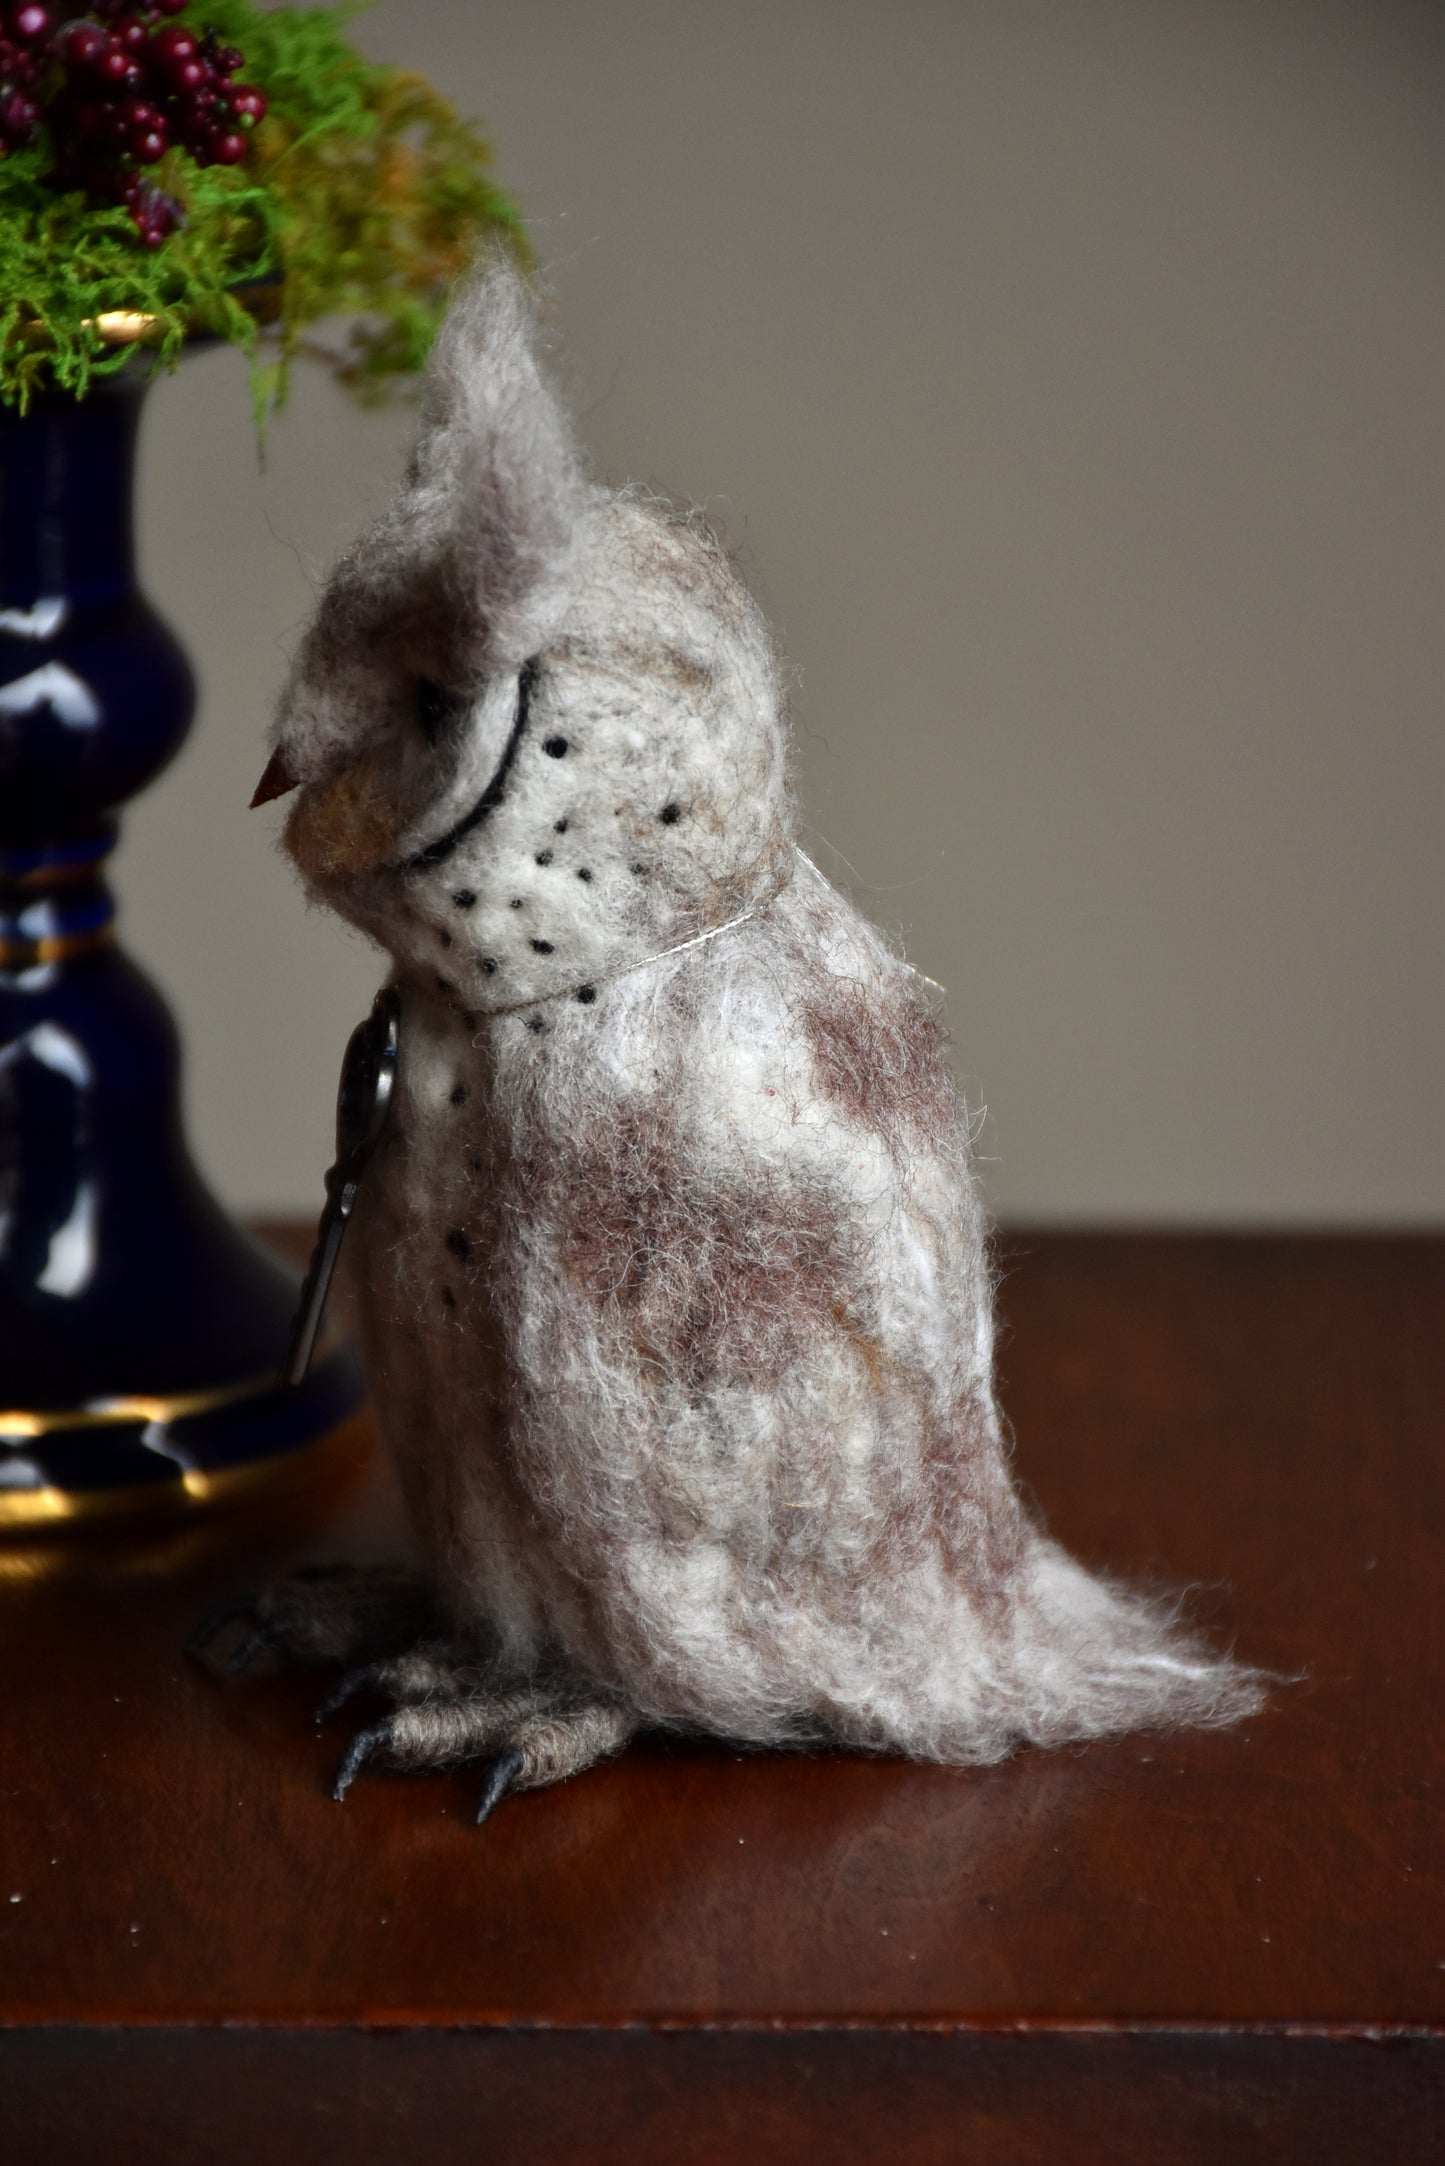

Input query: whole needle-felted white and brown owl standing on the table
[217,266,1259,1813]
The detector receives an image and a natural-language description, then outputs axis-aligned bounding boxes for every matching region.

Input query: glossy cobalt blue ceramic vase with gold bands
[0,362,360,1527]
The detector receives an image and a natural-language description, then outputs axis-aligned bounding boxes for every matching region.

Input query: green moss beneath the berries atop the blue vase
[0,0,526,420]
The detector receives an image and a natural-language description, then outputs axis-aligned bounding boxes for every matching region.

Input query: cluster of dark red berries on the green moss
[0,0,266,249]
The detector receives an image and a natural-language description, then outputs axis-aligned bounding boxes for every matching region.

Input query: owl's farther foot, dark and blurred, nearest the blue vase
[186,1564,435,1672]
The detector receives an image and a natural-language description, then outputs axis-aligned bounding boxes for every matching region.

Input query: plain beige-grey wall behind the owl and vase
[119,0,1445,1224]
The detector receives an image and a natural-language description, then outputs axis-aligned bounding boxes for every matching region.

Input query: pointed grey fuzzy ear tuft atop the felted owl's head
[409,256,587,669]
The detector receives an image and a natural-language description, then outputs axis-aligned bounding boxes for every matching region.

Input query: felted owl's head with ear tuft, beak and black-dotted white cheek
[265,262,791,1009]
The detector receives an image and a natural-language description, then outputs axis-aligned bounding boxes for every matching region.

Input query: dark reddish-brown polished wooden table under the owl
[0,1235,1445,2166]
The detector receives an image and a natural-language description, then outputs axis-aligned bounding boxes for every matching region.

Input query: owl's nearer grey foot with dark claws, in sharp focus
[323,1644,637,1822]
